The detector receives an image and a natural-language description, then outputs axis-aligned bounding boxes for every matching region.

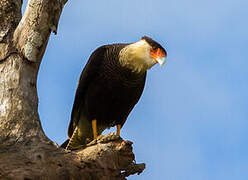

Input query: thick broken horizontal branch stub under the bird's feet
[0,134,145,180]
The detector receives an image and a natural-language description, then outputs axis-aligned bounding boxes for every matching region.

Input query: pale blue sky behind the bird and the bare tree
[22,0,248,180]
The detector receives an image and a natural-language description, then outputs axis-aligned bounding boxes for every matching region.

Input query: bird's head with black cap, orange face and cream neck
[119,36,167,72]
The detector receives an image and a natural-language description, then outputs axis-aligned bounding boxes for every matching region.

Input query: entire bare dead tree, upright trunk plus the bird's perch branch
[0,0,145,180]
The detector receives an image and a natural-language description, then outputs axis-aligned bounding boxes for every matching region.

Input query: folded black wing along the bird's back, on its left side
[68,46,107,137]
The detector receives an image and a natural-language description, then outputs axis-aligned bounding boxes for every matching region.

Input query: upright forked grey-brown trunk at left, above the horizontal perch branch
[0,0,66,149]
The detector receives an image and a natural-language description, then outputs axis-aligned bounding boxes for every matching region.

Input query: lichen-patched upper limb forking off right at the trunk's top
[14,0,67,62]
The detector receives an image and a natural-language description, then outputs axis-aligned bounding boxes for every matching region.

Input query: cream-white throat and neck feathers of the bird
[119,40,156,73]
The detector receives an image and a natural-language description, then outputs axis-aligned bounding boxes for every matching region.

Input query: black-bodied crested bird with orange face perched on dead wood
[61,36,167,150]
